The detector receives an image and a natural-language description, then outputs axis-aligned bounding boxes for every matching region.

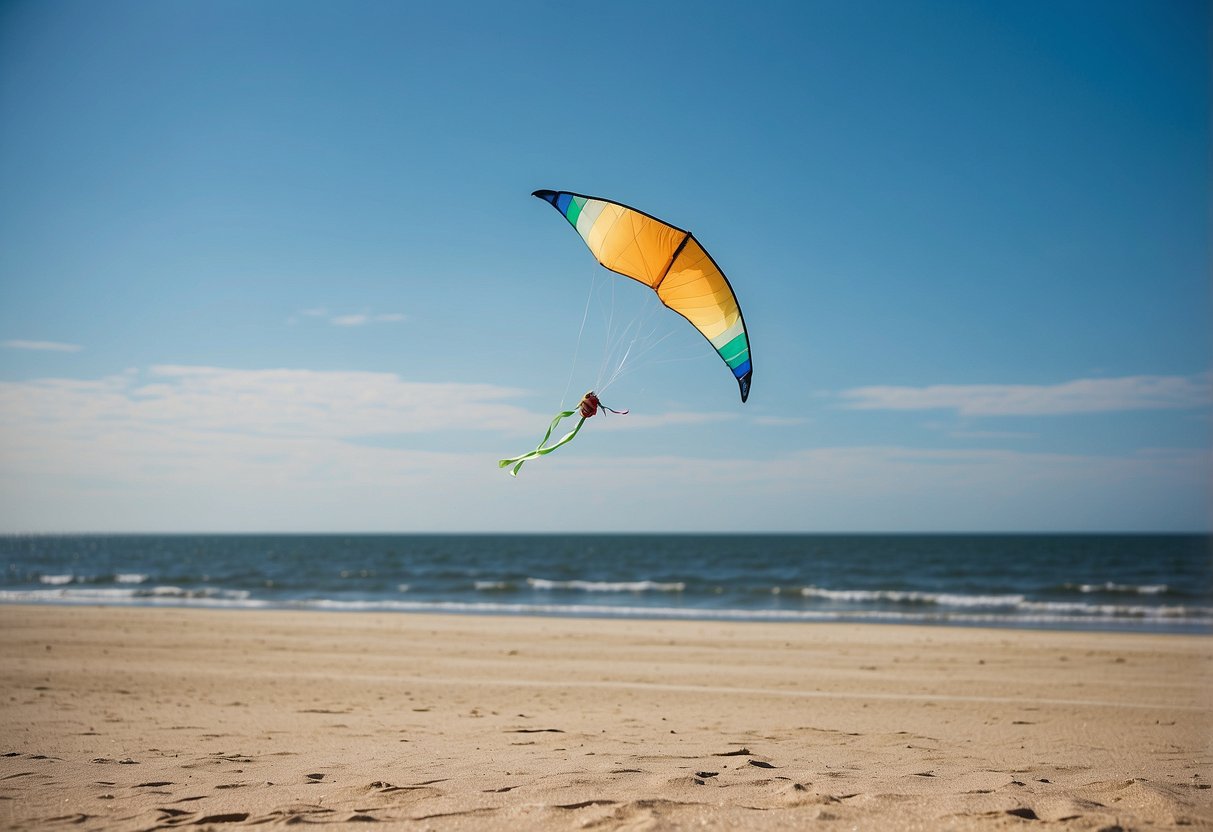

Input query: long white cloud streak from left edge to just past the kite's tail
[0,364,735,440]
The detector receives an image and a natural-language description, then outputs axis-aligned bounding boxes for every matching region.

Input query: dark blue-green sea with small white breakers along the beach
[0,534,1213,633]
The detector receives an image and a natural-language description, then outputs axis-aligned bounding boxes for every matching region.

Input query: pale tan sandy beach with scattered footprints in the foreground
[0,606,1213,831]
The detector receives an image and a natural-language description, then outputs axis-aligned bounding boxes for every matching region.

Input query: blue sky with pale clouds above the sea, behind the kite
[0,0,1213,531]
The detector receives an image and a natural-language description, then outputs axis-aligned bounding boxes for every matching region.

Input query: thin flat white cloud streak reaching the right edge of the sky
[839,374,1213,416]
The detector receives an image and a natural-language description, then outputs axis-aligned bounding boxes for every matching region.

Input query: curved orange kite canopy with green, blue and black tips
[533,190,753,401]
